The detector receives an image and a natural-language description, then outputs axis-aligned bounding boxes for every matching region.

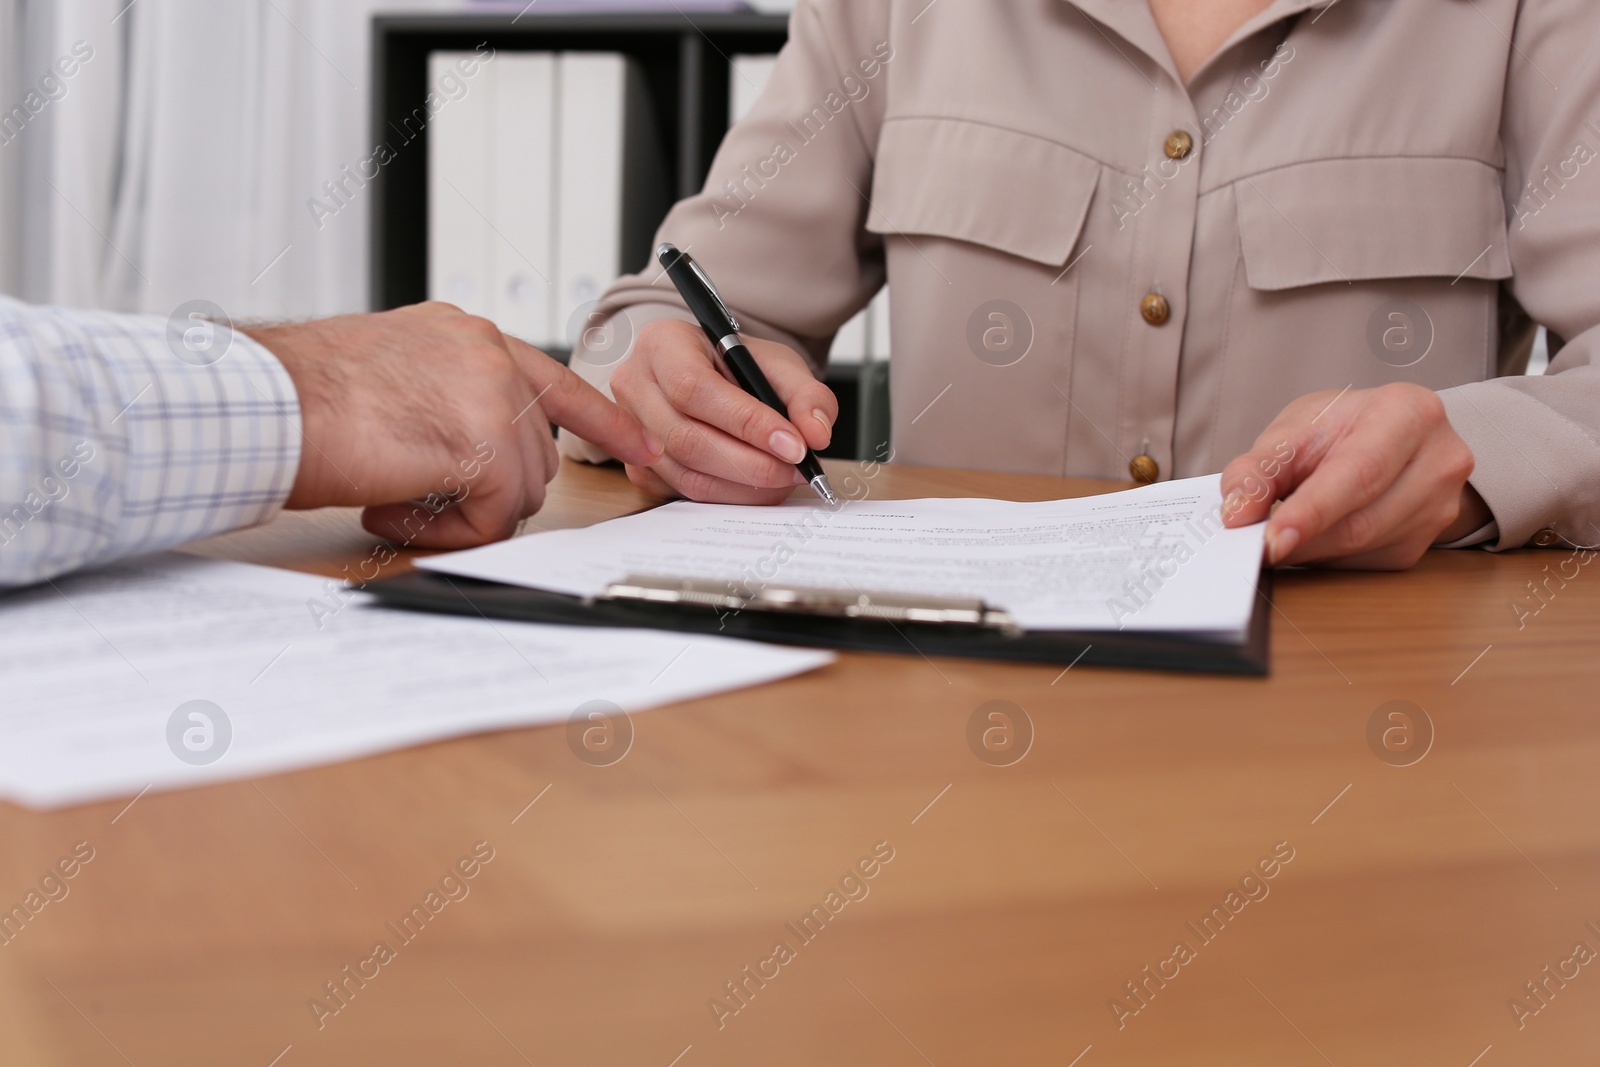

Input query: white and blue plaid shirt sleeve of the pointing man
[0,298,301,587]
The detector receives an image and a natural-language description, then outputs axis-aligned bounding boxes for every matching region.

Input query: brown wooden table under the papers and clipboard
[0,466,1600,1067]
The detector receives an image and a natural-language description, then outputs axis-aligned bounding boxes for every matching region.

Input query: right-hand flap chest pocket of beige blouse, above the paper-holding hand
[1229,157,1512,403]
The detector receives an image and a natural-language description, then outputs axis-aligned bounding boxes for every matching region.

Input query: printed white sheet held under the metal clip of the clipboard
[418,475,1264,640]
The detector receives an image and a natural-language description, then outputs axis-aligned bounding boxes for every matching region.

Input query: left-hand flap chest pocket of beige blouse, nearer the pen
[866,117,1101,470]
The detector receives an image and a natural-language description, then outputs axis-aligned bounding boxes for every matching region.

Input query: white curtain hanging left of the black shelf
[0,0,461,318]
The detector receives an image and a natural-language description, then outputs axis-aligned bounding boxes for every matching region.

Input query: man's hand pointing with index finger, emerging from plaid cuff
[246,304,661,549]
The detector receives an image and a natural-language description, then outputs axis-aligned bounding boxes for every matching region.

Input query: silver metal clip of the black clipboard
[600,574,1022,635]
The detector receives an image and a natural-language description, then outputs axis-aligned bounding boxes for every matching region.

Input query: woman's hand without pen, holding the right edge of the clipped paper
[1222,382,1490,569]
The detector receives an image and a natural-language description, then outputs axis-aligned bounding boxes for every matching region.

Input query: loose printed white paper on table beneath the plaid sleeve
[0,555,834,806]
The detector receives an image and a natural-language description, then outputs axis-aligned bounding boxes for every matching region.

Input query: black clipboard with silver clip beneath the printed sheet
[363,569,1272,677]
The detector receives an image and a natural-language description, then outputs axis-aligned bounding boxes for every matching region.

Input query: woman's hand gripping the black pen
[608,320,838,504]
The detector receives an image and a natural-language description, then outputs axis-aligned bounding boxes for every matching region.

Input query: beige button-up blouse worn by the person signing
[568,0,1600,547]
